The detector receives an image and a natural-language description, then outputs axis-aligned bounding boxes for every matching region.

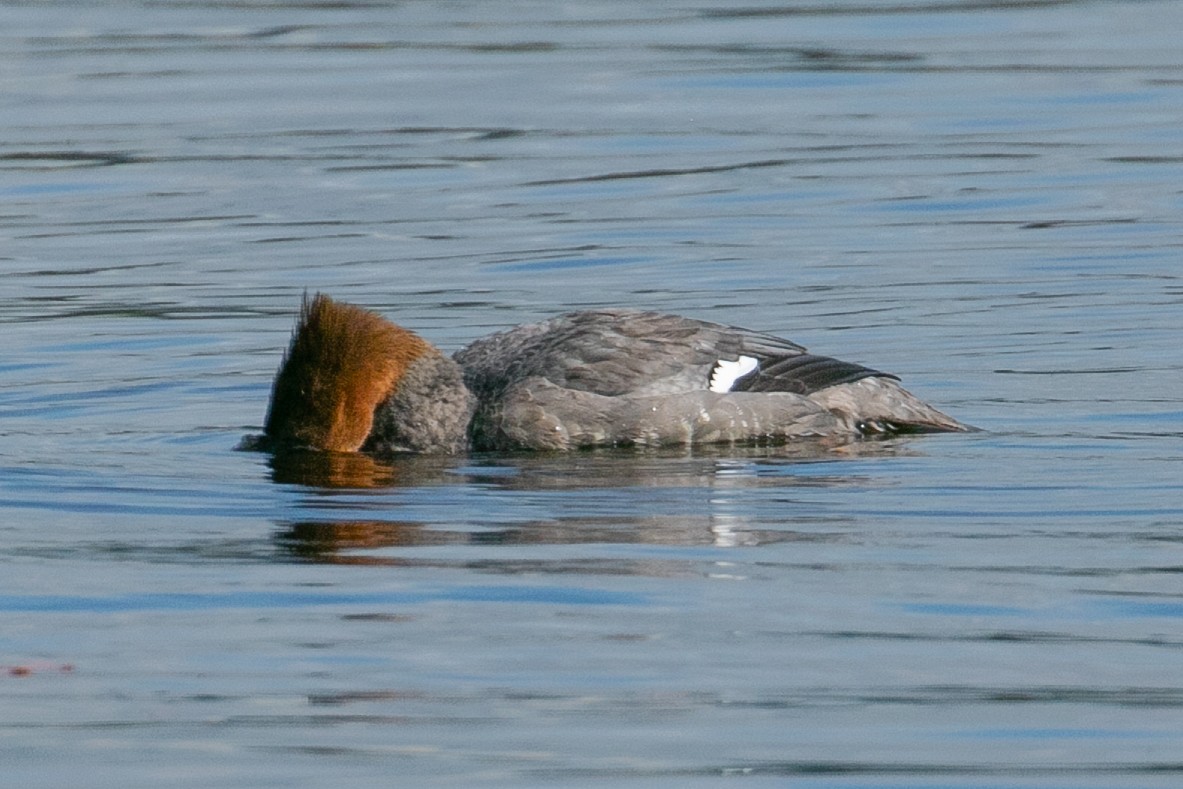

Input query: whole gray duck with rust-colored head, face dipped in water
[261,293,974,454]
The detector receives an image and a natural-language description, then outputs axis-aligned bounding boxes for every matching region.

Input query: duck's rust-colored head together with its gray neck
[264,293,472,452]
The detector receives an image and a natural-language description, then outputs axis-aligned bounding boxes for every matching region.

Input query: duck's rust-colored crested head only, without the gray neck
[264,293,432,452]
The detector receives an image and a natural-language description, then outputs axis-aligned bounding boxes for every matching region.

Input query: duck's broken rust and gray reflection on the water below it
[271,441,906,565]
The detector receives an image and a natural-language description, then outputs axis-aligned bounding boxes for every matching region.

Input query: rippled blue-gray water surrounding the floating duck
[0,1,1183,789]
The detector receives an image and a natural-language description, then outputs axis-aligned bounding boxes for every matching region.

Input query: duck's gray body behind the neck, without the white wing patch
[453,310,969,450]
